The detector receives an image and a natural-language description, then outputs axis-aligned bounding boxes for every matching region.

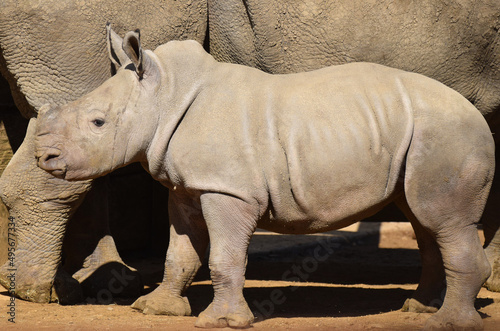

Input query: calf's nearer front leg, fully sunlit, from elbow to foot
[195,193,258,328]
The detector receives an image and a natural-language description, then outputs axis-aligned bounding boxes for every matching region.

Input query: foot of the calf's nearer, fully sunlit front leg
[195,301,254,328]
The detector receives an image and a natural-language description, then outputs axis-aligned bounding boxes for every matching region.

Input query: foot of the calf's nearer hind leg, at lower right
[424,309,483,331]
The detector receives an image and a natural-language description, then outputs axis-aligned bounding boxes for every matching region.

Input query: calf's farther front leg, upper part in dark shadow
[132,192,209,316]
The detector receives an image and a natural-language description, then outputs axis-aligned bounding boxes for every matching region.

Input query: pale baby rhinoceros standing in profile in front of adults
[36,30,494,329]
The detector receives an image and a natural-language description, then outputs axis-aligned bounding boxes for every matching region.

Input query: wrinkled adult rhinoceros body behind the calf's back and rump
[208,0,500,298]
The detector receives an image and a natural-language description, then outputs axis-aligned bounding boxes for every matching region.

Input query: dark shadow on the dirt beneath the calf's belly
[119,231,421,318]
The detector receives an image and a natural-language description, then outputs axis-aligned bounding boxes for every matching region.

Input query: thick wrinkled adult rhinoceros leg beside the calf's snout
[0,119,91,303]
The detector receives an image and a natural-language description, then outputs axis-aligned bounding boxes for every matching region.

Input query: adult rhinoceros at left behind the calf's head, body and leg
[0,0,207,303]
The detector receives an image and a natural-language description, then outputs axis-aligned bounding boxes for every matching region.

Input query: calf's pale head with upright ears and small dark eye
[36,26,160,180]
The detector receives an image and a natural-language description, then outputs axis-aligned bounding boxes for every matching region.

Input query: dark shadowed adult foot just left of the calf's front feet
[73,261,144,304]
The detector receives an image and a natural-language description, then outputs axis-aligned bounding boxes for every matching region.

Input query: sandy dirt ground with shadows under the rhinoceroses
[0,223,500,330]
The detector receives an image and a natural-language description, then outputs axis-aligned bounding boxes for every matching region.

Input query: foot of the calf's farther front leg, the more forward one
[132,285,191,316]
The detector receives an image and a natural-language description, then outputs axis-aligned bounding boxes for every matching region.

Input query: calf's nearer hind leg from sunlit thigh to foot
[405,129,494,330]
